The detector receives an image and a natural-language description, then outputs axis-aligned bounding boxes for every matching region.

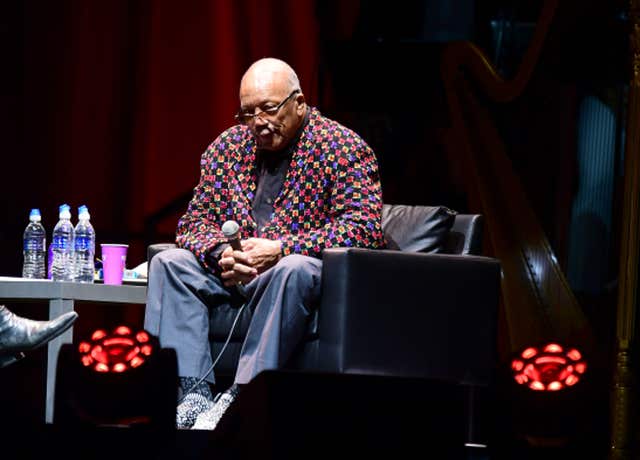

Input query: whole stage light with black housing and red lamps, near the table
[54,326,178,432]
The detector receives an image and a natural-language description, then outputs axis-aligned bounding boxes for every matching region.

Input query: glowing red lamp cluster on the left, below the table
[78,326,154,373]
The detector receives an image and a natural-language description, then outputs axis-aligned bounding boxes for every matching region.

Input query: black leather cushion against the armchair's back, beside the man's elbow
[382,204,456,253]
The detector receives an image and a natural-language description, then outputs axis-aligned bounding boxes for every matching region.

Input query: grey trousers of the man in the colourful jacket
[144,248,322,384]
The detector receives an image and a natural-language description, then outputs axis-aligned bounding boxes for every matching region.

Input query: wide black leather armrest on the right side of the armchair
[316,248,500,384]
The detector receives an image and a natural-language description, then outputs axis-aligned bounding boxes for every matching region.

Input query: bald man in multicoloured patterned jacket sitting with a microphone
[144,58,384,429]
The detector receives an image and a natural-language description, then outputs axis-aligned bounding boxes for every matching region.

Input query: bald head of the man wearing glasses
[240,58,307,151]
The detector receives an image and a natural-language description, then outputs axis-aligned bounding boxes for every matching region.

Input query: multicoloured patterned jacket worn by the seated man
[176,108,384,271]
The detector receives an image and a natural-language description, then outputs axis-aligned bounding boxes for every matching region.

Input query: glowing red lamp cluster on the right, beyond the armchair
[511,343,587,391]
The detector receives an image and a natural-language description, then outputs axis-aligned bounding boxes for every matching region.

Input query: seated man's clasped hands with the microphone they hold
[219,220,282,286]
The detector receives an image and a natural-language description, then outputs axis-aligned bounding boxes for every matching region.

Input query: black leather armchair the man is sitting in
[148,204,500,386]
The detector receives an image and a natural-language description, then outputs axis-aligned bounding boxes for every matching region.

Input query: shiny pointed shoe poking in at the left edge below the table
[0,305,78,367]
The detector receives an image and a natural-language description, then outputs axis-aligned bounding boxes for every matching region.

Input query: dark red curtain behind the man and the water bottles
[6,0,336,268]
